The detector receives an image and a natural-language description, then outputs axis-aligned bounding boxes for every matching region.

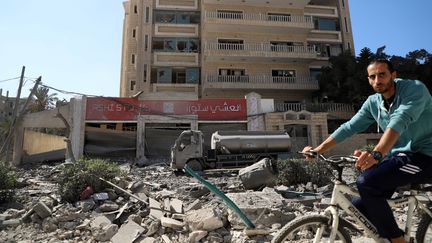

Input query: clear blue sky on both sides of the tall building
[0,0,432,99]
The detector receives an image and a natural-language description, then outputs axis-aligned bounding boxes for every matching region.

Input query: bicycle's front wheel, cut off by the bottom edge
[272,214,351,243]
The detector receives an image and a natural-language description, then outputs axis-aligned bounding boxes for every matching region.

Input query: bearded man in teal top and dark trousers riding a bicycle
[303,59,432,243]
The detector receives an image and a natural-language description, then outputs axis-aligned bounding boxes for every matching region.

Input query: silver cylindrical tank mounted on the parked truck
[211,131,291,154]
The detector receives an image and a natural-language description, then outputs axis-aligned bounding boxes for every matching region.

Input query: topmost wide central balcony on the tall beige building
[204,11,314,34]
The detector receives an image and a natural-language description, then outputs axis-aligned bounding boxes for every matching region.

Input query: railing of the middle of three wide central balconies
[204,42,317,58]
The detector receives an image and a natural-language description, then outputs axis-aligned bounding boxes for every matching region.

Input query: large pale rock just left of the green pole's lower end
[185,208,224,231]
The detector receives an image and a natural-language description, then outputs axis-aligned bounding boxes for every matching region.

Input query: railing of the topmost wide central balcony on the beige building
[205,12,313,28]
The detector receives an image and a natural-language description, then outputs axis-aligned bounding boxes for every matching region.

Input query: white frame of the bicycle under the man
[320,181,432,242]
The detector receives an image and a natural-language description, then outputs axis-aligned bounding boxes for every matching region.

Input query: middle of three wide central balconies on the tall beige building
[204,43,317,63]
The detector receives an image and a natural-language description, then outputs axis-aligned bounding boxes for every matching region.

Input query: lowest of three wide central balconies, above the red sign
[203,75,319,90]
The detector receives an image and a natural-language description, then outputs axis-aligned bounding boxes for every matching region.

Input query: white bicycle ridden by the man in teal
[272,152,432,243]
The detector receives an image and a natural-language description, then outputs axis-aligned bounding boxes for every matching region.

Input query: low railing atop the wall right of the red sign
[275,103,355,113]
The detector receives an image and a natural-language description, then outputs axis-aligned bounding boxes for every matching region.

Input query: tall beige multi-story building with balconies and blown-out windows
[120,0,354,107]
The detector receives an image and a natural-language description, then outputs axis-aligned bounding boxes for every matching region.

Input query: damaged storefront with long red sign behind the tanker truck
[83,97,247,159]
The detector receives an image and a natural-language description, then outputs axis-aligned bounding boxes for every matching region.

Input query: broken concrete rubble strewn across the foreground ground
[0,160,422,243]
